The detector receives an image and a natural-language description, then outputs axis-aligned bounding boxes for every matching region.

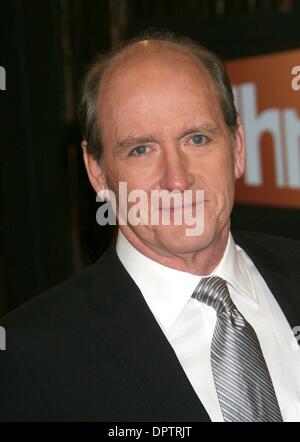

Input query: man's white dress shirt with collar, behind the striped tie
[116,231,300,422]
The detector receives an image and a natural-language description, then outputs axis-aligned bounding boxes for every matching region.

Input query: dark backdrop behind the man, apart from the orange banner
[0,0,300,315]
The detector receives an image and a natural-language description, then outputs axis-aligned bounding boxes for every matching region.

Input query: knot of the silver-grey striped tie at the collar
[192,276,236,315]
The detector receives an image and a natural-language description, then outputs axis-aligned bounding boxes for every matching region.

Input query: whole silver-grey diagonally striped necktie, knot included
[193,276,282,422]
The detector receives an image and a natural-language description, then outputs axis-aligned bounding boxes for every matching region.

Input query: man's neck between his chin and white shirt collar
[118,224,229,276]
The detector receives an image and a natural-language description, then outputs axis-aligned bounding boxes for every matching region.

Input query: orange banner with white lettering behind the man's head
[226,50,300,208]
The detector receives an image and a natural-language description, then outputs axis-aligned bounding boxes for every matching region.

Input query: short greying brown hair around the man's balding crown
[78,31,237,161]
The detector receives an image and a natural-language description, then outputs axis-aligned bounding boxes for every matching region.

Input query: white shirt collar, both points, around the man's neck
[116,230,255,332]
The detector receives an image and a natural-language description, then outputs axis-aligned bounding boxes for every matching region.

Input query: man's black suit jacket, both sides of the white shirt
[0,233,300,422]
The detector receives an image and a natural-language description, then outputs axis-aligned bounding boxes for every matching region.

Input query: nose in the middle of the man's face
[160,148,194,192]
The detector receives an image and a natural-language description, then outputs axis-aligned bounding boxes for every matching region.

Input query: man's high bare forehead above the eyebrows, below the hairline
[98,42,218,125]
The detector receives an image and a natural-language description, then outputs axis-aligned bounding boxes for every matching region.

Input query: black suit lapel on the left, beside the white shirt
[91,245,210,421]
